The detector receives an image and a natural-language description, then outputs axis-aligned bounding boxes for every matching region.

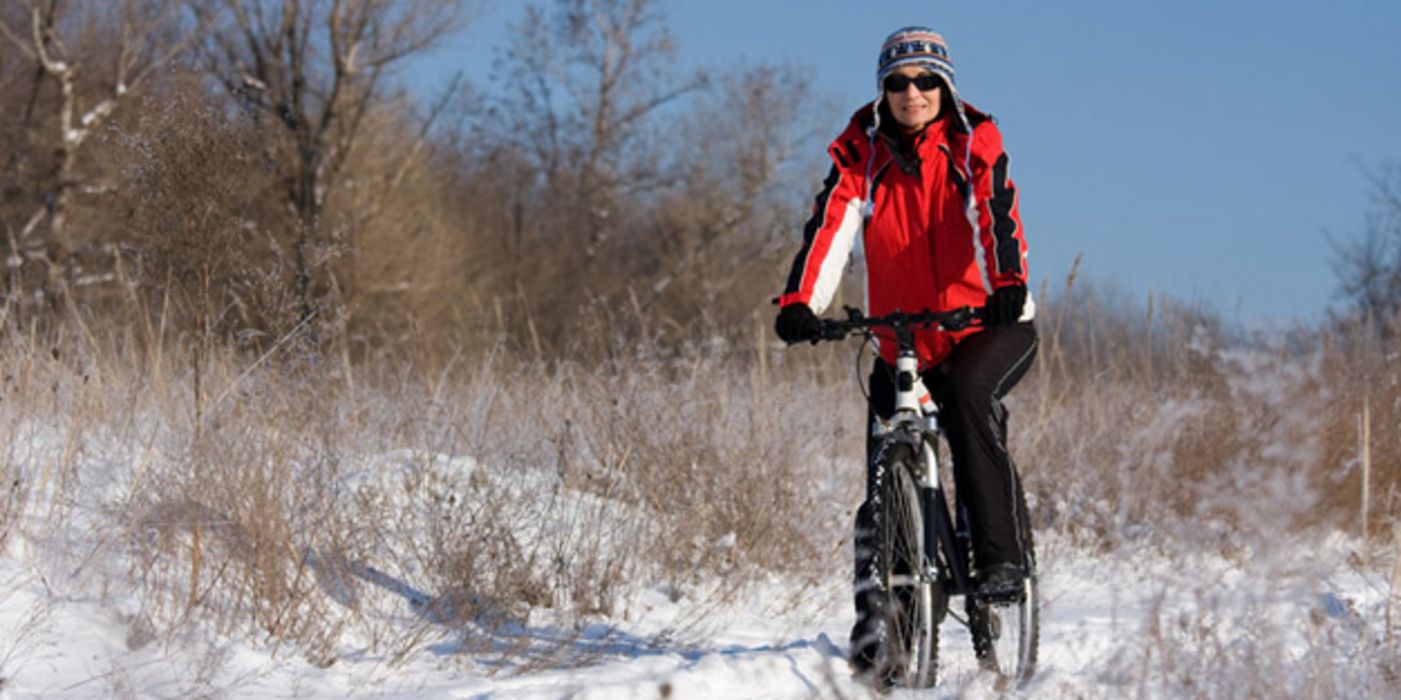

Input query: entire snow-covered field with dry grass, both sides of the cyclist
[0,330,1401,700]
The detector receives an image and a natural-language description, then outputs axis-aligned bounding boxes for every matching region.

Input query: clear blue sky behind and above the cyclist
[410,0,1401,323]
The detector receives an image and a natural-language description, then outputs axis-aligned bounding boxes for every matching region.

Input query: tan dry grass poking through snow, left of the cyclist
[0,303,859,664]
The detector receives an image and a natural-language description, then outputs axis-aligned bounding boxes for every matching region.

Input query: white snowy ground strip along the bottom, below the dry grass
[0,526,1397,699]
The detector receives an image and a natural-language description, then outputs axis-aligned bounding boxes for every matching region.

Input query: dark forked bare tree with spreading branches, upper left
[189,0,465,337]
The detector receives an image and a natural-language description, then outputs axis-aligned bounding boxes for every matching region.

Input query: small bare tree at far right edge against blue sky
[1334,162,1401,330]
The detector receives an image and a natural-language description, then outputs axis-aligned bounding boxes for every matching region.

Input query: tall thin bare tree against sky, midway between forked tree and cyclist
[490,0,706,260]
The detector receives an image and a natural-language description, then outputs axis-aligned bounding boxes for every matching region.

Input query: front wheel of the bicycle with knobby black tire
[876,441,943,687]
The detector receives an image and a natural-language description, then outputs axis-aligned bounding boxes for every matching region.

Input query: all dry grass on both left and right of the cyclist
[0,270,1397,672]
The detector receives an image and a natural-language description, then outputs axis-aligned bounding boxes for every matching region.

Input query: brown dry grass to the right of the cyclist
[1009,270,1401,550]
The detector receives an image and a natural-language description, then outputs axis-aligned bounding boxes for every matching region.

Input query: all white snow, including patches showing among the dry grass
[0,350,1401,700]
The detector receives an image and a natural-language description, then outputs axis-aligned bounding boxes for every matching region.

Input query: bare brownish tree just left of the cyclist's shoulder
[637,64,829,314]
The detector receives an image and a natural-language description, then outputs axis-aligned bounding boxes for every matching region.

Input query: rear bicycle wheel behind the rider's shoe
[968,477,1041,685]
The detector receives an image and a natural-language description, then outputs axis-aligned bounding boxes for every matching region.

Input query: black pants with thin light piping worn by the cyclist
[852,322,1037,654]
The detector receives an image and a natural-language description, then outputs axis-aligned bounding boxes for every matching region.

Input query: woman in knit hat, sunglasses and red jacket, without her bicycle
[775,27,1037,672]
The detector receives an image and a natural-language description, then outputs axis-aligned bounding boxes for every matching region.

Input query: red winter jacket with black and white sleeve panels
[779,102,1035,367]
